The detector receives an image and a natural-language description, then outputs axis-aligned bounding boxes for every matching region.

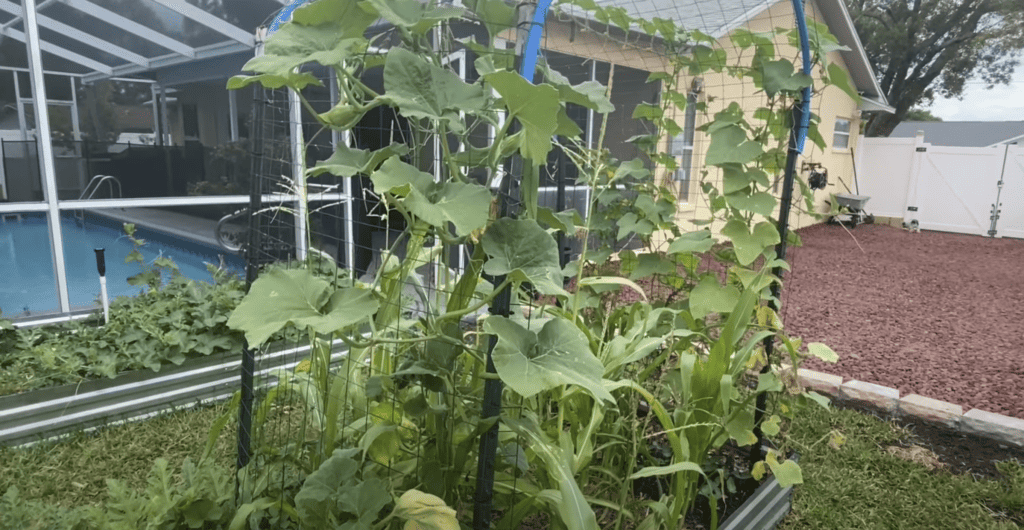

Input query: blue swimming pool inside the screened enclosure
[0,212,245,318]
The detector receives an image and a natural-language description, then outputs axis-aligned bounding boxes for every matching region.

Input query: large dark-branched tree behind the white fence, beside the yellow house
[847,0,1024,136]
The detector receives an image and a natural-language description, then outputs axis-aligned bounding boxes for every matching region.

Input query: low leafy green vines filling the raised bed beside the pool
[0,241,244,395]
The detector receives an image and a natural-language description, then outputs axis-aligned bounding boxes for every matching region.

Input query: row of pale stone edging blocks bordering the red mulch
[783,366,1024,448]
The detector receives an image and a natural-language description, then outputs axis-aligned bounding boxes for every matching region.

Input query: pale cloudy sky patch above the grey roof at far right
[929,65,1024,122]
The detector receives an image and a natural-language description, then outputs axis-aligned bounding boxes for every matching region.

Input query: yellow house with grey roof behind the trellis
[516,0,893,235]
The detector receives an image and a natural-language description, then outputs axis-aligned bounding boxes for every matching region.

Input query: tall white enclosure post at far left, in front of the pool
[22,0,71,313]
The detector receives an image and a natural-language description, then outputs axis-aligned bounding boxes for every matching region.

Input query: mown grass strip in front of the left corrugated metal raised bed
[0,403,236,507]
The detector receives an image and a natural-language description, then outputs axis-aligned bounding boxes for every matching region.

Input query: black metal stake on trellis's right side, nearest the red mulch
[750,104,803,466]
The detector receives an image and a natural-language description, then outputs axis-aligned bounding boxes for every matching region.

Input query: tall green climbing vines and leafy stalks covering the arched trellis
[218,0,842,530]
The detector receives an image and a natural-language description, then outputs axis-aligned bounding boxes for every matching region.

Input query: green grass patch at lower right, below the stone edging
[780,407,1024,530]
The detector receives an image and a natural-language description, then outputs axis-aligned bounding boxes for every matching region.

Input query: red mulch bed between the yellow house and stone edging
[782,225,1024,418]
